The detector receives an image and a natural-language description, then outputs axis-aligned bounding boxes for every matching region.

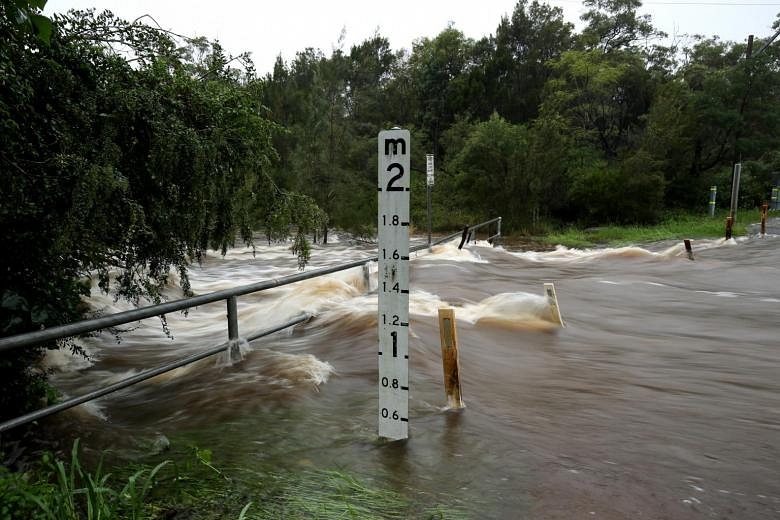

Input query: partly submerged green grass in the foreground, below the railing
[0,441,467,520]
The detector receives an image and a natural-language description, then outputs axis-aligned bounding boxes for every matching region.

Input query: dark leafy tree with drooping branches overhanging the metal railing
[0,8,322,418]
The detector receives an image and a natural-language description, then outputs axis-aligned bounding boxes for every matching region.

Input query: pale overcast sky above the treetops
[45,0,780,73]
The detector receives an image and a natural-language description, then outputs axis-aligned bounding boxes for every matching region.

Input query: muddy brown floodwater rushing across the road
[48,222,780,519]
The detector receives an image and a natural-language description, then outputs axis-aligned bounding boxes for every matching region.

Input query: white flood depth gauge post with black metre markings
[377,129,411,440]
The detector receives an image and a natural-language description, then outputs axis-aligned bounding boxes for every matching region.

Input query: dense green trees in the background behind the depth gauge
[253,0,780,235]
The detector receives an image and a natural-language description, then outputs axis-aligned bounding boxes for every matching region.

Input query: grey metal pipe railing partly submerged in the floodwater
[0,217,501,433]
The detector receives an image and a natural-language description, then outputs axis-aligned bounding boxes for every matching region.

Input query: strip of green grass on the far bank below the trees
[538,210,760,248]
